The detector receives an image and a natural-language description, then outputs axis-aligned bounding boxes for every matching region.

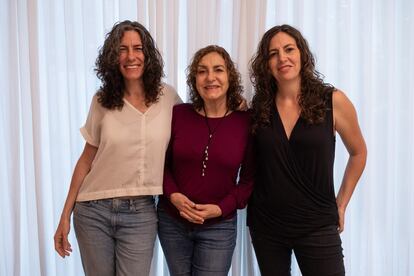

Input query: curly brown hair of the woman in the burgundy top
[187,45,243,110]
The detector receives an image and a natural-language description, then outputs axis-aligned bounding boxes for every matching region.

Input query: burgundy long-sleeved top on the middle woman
[160,104,254,223]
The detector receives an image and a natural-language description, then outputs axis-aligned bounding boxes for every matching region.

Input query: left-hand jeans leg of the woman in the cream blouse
[73,201,115,276]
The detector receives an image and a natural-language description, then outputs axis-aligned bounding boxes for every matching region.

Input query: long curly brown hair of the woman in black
[250,25,334,131]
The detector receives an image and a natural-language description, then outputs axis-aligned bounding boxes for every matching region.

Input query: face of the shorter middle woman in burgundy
[196,52,229,106]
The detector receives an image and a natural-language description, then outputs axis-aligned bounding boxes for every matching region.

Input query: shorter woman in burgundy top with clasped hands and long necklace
[158,45,253,276]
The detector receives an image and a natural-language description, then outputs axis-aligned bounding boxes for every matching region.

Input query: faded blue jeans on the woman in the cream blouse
[73,196,157,276]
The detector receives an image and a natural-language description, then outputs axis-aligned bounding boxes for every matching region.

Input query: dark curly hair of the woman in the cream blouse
[95,20,164,109]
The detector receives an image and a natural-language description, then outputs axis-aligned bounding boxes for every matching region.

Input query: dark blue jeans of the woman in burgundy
[158,209,237,276]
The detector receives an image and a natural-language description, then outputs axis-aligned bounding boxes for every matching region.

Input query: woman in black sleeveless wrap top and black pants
[247,25,367,276]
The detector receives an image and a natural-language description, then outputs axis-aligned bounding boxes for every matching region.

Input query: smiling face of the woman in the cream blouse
[119,31,145,81]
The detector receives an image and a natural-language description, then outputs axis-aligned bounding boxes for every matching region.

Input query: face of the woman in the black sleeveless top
[268,32,301,83]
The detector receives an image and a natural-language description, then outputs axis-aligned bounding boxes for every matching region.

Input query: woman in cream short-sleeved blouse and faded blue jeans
[54,21,179,276]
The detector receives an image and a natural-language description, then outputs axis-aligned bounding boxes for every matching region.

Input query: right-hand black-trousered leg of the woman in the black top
[294,226,345,276]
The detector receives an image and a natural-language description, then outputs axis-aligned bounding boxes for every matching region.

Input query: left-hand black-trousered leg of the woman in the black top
[249,229,292,276]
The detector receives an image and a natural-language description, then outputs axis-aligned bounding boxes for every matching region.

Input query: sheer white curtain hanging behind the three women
[0,0,414,276]
